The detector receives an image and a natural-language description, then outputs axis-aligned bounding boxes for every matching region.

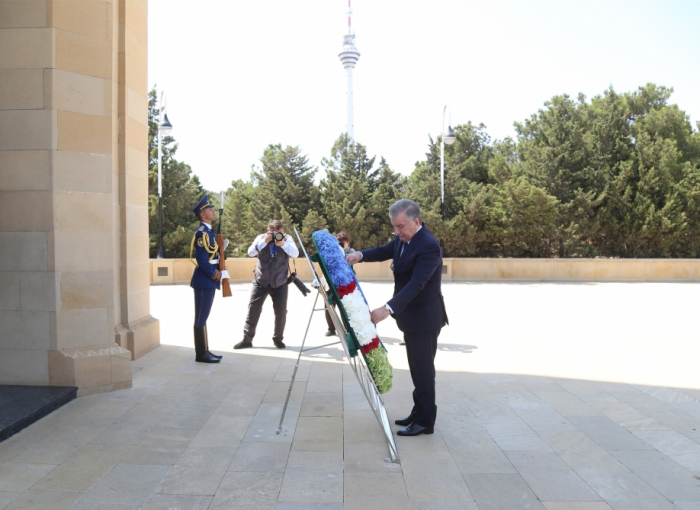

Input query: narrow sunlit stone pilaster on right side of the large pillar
[113,0,160,359]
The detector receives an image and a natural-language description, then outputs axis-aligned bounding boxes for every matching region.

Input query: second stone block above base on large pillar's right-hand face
[61,270,114,310]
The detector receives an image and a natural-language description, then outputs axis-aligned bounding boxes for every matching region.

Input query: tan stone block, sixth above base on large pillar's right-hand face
[56,111,112,154]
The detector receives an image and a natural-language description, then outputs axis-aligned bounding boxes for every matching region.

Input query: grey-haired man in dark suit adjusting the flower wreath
[346,199,447,436]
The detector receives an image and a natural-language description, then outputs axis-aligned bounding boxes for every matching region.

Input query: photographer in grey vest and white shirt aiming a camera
[233,220,299,349]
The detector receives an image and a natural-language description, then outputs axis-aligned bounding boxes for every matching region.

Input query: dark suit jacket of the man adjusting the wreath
[362,225,447,332]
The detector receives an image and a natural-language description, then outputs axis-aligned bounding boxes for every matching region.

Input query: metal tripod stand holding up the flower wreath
[277,227,401,464]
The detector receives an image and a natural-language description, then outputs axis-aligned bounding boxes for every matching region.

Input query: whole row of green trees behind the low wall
[149,84,700,257]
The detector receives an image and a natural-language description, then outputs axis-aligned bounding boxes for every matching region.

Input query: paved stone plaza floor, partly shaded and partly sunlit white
[0,283,700,510]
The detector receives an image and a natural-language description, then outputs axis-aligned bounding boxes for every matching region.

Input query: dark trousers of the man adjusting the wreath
[403,329,440,427]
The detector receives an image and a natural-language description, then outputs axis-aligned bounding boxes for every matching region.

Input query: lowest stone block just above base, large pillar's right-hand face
[56,308,114,349]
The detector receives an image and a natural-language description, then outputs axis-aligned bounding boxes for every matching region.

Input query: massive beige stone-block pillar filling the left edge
[0,0,157,395]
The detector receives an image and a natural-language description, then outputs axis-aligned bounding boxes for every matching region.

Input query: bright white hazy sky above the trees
[148,0,700,191]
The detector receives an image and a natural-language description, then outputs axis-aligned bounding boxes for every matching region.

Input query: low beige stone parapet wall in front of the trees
[150,258,700,285]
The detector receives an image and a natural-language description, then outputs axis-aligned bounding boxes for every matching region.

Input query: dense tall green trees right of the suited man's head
[408,84,700,257]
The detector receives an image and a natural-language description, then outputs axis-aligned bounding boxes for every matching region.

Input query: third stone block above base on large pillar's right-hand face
[51,230,114,271]
